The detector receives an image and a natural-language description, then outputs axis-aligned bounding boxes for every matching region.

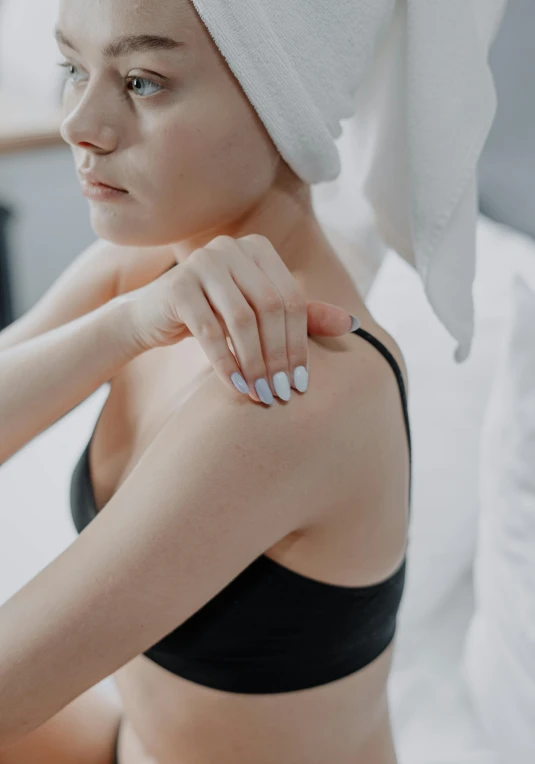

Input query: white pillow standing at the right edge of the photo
[463,268,535,764]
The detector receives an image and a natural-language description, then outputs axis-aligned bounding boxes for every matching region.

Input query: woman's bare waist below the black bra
[114,644,395,764]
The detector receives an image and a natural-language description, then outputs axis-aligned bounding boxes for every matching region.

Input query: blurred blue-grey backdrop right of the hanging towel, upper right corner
[478,0,535,238]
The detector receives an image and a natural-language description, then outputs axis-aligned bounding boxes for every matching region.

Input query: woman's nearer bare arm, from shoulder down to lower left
[0,338,362,748]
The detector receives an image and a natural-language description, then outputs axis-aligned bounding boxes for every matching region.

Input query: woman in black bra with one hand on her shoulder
[0,0,410,764]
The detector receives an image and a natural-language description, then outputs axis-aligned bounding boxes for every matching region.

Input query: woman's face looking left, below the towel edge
[57,0,288,246]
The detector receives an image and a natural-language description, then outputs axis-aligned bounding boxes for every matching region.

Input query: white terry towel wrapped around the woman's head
[193,0,506,363]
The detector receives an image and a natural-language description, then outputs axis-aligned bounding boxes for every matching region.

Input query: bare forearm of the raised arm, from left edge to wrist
[0,299,140,465]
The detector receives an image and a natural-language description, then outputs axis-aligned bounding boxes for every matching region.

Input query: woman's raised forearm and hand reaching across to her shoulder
[0,235,358,465]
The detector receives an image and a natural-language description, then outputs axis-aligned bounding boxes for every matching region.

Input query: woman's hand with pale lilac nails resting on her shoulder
[118,235,356,404]
